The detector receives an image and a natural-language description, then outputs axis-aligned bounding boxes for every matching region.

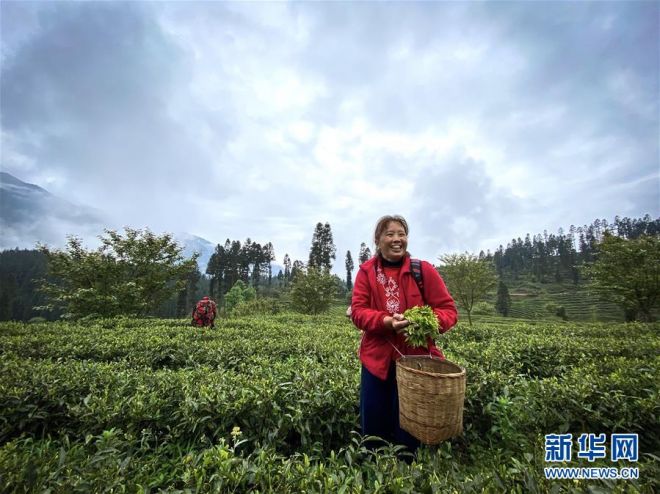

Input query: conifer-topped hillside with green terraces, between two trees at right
[464,215,660,321]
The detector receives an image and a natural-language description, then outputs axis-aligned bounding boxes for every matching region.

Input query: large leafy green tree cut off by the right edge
[584,234,660,321]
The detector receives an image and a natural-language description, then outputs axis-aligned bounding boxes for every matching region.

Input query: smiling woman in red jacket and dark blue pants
[350,216,458,452]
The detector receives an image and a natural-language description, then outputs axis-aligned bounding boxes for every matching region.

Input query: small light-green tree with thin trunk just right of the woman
[440,252,497,325]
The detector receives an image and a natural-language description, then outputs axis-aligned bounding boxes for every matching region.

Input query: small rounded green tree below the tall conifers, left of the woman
[291,268,337,314]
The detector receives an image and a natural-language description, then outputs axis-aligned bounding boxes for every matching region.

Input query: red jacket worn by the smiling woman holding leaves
[351,255,458,380]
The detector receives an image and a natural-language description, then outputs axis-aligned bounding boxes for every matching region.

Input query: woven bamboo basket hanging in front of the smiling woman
[396,355,465,444]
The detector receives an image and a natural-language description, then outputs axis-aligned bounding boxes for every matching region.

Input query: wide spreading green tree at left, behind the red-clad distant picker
[39,228,197,318]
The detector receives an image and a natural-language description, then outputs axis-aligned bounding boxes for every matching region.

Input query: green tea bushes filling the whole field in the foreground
[0,314,660,493]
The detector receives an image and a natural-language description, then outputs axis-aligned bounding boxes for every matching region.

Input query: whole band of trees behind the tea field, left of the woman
[0,222,345,321]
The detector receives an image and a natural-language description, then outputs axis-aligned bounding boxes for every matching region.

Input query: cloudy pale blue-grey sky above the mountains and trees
[0,0,660,272]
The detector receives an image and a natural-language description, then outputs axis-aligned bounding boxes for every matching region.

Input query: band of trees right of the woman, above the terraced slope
[438,215,660,324]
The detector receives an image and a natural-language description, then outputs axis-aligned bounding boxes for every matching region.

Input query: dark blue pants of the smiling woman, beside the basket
[360,362,420,453]
